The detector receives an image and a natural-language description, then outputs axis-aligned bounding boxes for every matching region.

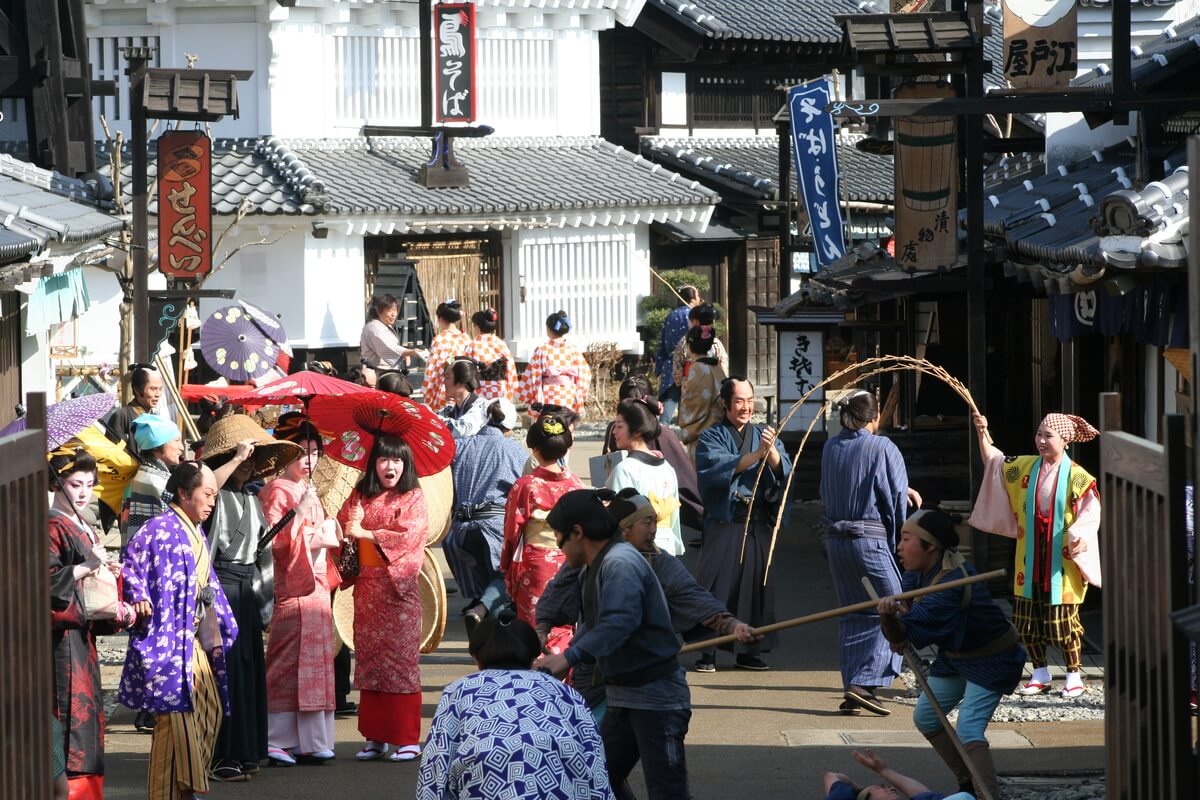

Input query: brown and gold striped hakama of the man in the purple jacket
[149,642,221,800]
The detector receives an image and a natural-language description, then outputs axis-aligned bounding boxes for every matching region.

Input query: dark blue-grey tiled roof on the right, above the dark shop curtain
[984,145,1188,293]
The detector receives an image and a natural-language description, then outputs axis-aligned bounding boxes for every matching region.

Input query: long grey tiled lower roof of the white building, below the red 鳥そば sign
[110,137,719,216]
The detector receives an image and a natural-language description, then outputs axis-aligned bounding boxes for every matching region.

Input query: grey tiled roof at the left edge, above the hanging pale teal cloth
[0,154,122,250]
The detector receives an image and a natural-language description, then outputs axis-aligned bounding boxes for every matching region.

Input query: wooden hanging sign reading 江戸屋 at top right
[1004,0,1079,89]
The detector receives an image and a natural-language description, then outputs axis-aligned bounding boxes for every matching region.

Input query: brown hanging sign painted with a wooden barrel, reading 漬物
[895,82,959,272]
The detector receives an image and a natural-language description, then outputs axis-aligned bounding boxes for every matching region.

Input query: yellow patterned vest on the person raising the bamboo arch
[1003,456,1096,606]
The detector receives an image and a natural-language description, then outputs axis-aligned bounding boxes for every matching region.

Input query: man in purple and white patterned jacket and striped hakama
[118,462,238,800]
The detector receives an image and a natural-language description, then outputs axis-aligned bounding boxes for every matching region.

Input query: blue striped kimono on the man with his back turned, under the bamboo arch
[821,428,908,688]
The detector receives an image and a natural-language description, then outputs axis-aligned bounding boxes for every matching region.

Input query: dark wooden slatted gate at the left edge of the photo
[0,395,54,800]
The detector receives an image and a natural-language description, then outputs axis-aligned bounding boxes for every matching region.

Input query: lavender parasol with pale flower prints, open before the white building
[200,303,287,380]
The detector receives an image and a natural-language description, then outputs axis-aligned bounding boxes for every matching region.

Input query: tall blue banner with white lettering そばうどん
[787,78,846,266]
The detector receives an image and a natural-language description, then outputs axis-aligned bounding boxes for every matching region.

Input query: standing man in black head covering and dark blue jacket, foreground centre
[534,489,691,800]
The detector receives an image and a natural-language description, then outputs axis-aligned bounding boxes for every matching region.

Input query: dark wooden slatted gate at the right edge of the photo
[1099,393,1200,800]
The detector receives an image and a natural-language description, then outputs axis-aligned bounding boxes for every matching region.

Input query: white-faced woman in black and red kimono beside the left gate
[50,450,134,800]
